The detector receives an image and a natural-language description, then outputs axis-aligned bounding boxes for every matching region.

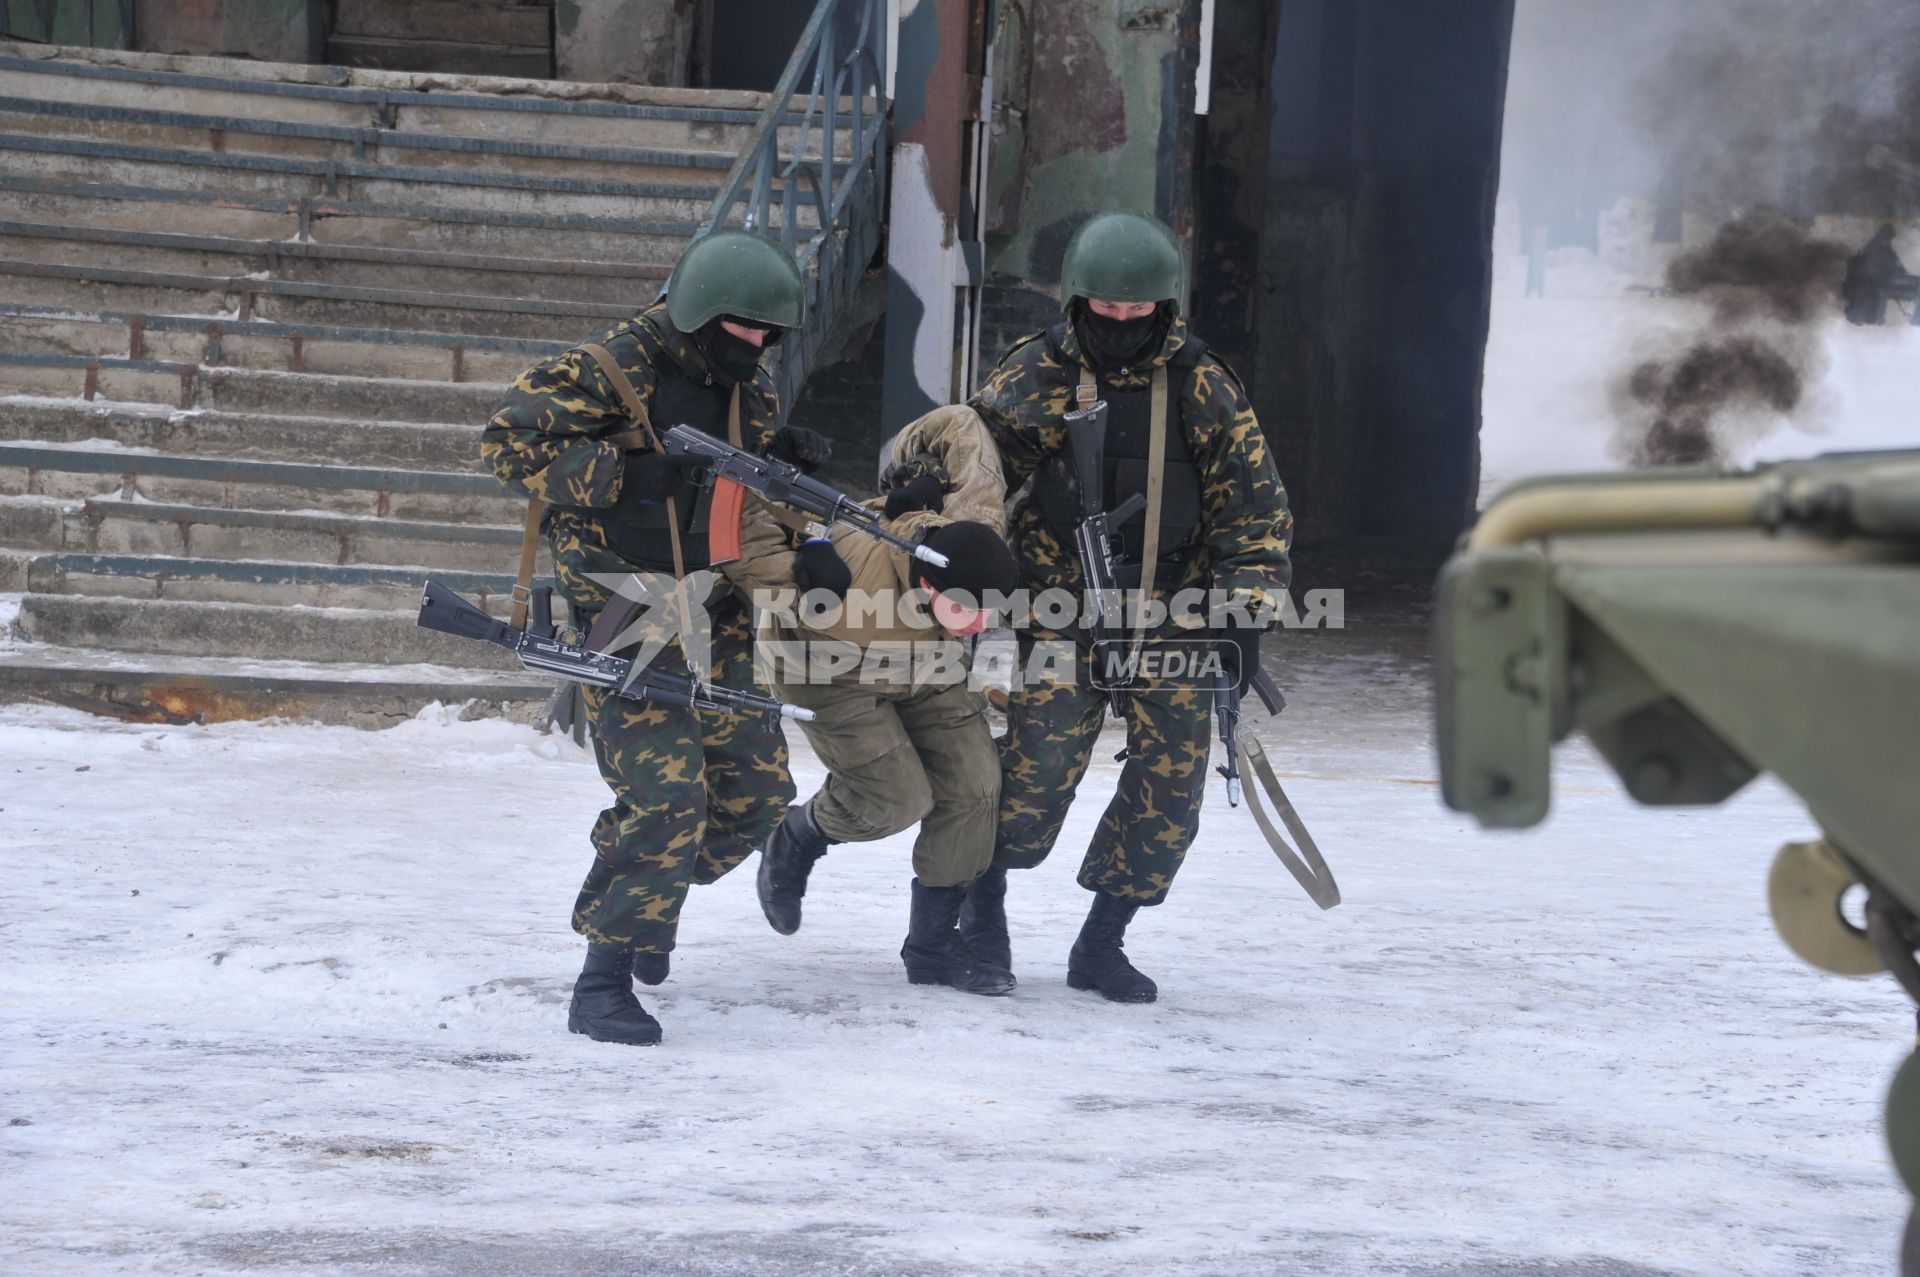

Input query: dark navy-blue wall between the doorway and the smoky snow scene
[1250,0,1513,557]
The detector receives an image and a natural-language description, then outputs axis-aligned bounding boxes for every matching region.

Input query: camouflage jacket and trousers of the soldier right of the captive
[970,317,1294,904]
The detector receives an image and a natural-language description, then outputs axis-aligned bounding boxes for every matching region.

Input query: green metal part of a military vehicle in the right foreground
[1434,451,1920,1277]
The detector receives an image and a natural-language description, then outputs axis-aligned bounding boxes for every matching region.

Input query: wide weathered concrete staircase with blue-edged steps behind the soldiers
[0,39,817,724]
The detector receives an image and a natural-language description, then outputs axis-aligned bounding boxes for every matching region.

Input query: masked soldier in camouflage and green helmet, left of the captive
[480,230,828,1045]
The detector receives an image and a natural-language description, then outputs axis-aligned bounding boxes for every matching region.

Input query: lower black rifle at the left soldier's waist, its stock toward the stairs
[419,582,814,726]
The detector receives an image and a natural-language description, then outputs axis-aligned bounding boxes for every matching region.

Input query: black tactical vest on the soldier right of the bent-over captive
[1033,323,1206,586]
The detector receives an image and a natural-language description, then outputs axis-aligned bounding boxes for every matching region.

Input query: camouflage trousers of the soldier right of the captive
[993,630,1213,904]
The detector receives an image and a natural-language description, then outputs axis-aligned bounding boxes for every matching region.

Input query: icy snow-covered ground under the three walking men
[0,628,1912,1277]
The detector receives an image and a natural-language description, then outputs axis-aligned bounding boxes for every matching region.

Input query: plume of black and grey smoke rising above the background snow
[1615,0,1920,467]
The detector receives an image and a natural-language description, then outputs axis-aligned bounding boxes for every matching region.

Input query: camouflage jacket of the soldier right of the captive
[968,319,1294,609]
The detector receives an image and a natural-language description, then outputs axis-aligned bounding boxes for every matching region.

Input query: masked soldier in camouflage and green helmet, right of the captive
[960,213,1292,1002]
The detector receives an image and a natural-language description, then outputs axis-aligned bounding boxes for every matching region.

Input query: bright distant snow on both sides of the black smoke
[1480,238,1920,503]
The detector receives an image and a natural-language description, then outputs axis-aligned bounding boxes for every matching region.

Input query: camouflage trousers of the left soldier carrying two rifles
[574,593,793,952]
